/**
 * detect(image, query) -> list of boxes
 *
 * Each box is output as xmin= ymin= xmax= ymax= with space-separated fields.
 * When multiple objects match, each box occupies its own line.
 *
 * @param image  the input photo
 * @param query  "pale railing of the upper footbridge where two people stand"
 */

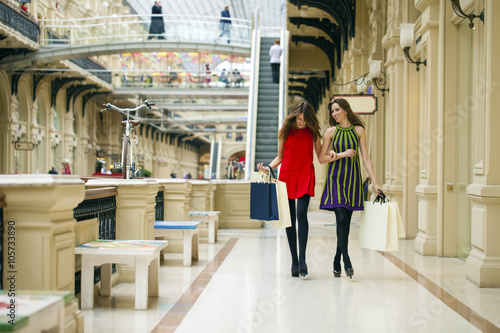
xmin=39 ymin=15 xmax=251 ymax=47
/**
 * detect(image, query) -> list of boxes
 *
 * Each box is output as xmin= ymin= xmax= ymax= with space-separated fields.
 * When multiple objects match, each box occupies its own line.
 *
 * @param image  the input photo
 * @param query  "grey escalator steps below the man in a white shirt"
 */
xmin=255 ymin=37 xmax=279 ymax=165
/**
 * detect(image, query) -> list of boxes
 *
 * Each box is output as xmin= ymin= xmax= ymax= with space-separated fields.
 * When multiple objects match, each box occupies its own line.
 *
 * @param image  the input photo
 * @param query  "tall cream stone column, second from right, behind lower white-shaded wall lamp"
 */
xmin=412 ymin=0 xmax=442 ymax=255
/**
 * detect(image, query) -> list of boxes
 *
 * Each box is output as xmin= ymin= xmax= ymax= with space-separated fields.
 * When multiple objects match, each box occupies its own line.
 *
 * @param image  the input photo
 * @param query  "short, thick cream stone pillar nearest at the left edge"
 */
xmin=0 ymin=175 xmax=85 ymax=290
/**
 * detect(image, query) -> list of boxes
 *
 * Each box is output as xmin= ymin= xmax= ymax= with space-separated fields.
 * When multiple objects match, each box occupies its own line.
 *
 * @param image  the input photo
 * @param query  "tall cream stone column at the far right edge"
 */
xmin=466 ymin=0 xmax=500 ymax=287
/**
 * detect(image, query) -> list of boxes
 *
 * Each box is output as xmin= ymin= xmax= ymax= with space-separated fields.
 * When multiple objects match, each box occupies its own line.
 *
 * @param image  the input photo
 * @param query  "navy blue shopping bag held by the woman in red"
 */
xmin=250 ymin=170 xmax=279 ymax=221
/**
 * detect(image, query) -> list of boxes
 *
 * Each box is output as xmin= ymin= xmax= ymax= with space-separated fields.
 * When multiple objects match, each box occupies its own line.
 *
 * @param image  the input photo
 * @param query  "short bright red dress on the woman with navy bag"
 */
xmin=278 ymin=127 xmax=316 ymax=199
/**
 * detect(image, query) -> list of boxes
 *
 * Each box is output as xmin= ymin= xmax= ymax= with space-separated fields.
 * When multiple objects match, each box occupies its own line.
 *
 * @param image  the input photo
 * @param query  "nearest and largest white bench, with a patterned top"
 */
xmin=75 ymin=239 xmax=167 ymax=310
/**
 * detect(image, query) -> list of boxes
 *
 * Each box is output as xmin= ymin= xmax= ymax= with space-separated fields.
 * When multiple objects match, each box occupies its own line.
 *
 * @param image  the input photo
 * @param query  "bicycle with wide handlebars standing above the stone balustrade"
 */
xmin=101 ymin=101 xmax=154 ymax=179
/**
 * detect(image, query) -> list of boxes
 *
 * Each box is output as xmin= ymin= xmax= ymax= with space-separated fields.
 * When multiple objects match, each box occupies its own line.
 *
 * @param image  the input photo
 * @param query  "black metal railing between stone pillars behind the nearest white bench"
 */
xmin=73 ymin=187 xmax=118 ymax=295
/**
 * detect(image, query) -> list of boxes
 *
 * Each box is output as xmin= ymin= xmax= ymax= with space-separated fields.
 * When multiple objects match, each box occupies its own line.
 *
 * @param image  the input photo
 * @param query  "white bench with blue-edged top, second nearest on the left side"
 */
xmin=155 ymin=221 xmax=202 ymax=266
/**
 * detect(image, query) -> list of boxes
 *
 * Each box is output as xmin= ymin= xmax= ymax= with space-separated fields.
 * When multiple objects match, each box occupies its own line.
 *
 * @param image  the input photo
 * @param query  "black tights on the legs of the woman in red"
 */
xmin=285 ymin=194 xmax=311 ymax=265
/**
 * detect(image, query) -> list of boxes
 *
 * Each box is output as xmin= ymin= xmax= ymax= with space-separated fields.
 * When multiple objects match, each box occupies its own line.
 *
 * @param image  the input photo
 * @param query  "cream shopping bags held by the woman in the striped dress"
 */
xmin=359 ymin=196 xmax=405 ymax=251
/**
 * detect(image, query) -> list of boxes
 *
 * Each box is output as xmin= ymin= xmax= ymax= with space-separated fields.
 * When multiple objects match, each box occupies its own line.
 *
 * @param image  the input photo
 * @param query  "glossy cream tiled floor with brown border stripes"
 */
xmin=82 ymin=212 xmax=500 ymax=333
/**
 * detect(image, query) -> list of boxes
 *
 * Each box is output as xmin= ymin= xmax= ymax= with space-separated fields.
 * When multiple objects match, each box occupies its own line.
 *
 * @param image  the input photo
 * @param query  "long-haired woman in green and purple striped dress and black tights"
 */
xmin=319 ymin=98 xmax=383 ymax=278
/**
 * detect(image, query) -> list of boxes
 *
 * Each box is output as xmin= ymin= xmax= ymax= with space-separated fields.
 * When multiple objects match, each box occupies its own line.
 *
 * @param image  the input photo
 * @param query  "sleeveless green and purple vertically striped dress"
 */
xmin=319 ymin=125 xmax=364 ymax=210
